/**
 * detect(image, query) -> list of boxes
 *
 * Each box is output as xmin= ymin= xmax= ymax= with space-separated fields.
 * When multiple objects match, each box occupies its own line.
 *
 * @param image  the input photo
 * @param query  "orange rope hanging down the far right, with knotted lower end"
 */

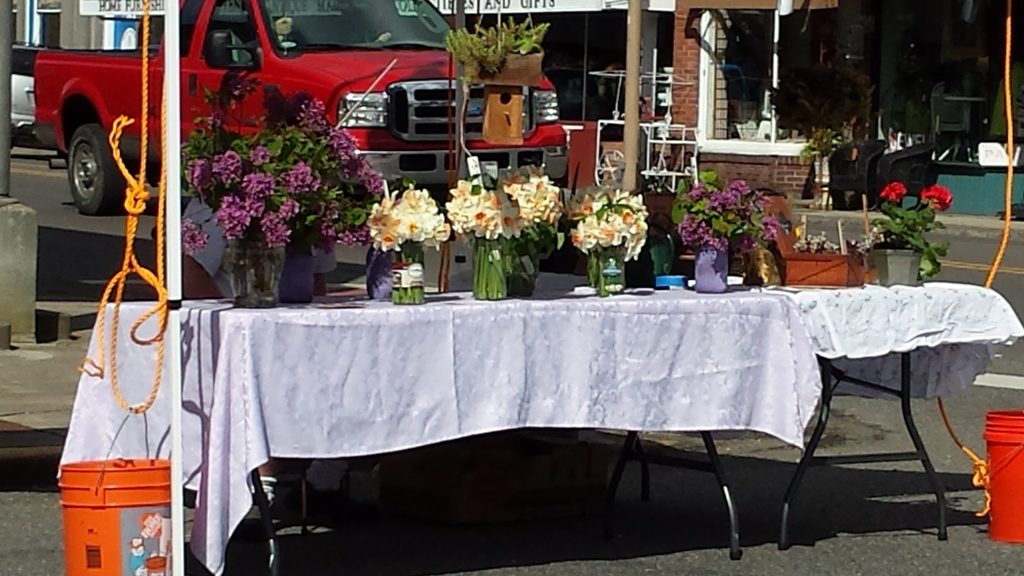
xmin=938 ymin=0 xmax=1016 ymax=517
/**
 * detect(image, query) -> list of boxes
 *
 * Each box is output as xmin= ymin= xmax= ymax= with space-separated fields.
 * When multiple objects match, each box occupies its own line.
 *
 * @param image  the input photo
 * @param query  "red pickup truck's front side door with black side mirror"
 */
xmin=181 ymin=0 xmax=262 ymax=131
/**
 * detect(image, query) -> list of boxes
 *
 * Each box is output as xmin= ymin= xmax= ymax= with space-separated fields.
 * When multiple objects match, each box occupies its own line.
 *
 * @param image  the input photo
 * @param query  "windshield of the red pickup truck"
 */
xmin=260 ymin=0 xmax=449 ymax=52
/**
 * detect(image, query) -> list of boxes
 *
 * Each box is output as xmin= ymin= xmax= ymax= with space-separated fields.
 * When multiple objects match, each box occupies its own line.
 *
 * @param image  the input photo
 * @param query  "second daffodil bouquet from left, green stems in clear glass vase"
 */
xmin=445 ymin=178 xmax=523 ymax=300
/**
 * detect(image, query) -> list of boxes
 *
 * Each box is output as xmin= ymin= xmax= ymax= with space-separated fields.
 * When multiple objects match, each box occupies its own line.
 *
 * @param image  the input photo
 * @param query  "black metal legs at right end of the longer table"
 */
xmin=604 ymin=431 xmax=743 ymax=560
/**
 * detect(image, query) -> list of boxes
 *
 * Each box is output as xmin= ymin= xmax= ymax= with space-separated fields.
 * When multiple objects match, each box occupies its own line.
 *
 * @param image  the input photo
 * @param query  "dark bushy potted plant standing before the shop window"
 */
xmin=771 ymin=65 xmax=873 ymax=206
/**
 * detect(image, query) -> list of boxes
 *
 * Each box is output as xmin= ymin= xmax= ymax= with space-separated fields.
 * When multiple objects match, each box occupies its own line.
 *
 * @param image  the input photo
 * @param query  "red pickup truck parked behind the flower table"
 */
xmin=35 ymin=0 xmax=566 ymax=214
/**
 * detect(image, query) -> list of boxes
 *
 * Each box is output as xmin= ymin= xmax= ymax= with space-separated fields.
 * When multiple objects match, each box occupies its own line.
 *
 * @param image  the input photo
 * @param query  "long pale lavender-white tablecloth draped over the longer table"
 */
xmin=62 ymin=292 xmax=820 ymax=574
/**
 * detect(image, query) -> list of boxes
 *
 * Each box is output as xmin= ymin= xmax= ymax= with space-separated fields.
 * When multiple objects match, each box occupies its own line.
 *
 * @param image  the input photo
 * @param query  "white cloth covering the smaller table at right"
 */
xmin=768 ymin=282 xmax=1024 ymax=398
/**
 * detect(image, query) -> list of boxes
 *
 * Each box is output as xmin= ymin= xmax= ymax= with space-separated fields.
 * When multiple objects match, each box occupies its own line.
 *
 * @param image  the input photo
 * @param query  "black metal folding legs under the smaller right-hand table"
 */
xmin=778 ymin=353 xmax=947 ymax=550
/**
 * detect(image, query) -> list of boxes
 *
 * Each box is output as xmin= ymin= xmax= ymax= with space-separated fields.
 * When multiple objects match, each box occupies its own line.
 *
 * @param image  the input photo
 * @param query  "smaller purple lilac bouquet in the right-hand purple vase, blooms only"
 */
xmin=674 ymin=171 xmax=779 ymax=251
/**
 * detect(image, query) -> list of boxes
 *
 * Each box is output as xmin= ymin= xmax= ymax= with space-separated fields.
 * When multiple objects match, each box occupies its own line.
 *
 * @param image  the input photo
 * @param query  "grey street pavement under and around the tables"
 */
xmin=0 ymin=150 xmax=1024 ymax=576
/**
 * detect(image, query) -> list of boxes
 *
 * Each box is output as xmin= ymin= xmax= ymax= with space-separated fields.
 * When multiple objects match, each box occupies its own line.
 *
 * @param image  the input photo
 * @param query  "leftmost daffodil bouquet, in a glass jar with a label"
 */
xmin=370 ymin=187 xmax=452 ymax=304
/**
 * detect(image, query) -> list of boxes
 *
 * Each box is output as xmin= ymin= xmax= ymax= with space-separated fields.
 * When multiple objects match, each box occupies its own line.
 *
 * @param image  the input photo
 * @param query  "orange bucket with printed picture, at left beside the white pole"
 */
xmin=59 ymin=460 xmax=171 ymax=576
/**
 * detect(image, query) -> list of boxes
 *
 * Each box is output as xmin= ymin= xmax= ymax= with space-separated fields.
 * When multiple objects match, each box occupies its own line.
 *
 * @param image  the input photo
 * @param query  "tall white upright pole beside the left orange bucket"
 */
xmin=162 ymin=1 xmax=185 ymax=576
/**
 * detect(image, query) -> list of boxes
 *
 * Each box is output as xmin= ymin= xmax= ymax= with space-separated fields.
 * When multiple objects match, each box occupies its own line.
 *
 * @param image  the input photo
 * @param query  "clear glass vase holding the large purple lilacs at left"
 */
xmin=224 ymin=239 xmax=285 ymax=308
